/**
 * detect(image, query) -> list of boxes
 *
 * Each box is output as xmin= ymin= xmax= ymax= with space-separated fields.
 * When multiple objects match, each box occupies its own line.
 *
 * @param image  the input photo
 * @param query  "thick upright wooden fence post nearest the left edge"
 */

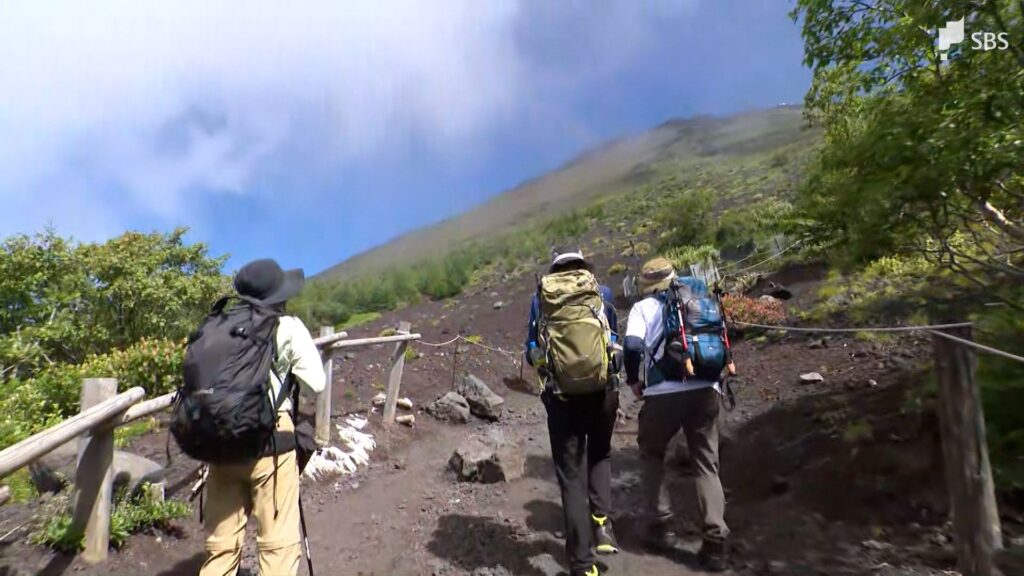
xmin=72 ymin=378 xmax=118 ymax=564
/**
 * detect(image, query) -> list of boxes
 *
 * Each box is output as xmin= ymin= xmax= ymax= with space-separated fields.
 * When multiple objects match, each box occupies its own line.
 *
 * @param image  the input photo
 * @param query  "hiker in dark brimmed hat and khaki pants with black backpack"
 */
xmin=172 ymin=259 xmax=326 ymax=576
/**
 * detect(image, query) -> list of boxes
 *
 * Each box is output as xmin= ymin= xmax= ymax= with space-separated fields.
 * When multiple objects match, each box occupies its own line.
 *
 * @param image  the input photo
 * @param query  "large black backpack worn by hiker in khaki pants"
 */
xmin=170 ymin=297 xmax=290 ymax=464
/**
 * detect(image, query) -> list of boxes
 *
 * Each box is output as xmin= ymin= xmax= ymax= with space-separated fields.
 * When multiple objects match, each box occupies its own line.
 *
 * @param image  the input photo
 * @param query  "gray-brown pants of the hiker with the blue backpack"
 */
xmin=637 ymin=387 xmax=729 ymax=543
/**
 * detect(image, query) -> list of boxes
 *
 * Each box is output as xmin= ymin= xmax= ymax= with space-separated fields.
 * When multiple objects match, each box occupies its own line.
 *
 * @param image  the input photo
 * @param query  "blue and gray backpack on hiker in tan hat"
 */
xmin=657 ymin=276 xmax=729 ymax=381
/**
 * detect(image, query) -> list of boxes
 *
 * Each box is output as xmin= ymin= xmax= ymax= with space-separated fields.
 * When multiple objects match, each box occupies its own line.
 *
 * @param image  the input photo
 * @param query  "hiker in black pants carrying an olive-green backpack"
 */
xmin=525 ymin=248 xmax=622 ymax=576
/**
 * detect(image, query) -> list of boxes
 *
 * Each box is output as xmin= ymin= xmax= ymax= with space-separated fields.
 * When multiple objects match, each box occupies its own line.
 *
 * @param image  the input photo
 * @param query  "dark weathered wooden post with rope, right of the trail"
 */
xmin=932 ymin=328 xmax=1002 ymax=576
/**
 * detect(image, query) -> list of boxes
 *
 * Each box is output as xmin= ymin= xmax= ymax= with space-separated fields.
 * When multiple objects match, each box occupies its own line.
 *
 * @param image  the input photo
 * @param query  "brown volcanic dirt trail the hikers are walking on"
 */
xmin=0 ymin=261 xmax=1021 ymax=576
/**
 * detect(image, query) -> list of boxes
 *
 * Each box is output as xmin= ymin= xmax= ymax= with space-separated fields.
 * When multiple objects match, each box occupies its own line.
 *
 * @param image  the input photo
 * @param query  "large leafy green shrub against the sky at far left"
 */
xmin=0 ymin=229 xmax=229 ymax=379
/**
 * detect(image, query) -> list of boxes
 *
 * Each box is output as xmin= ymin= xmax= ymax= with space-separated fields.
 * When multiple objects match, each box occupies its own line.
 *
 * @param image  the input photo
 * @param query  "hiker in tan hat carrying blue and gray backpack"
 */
xmin=624 ymin=258 xmax=731 ymax=571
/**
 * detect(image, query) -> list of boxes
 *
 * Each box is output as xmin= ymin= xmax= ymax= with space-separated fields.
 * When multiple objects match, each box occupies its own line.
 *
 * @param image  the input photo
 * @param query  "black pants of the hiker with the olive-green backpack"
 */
xmin=541 ymin=390 xmax=618 ymax=574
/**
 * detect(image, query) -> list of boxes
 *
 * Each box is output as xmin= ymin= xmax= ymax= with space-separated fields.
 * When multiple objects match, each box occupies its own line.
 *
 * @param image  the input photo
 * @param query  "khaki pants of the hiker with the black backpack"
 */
xmin=200 ymin=414 xmax=302 ymax=576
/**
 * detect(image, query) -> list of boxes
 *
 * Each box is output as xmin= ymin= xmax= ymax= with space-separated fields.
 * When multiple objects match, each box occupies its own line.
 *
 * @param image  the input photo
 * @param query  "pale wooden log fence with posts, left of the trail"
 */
xmin=0 ymin=322 xmax=420 ymax=564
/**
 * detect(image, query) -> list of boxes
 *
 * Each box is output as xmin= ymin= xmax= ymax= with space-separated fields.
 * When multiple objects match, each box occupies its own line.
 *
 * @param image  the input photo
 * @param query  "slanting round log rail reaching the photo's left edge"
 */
xmin=0 ymin=387 xmax=145 ymax=478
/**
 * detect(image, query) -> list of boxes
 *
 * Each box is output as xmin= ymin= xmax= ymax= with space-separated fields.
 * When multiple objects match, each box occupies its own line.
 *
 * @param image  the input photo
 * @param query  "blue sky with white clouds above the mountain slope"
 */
xmin=0 ymin=0 xmax=810 ymax=274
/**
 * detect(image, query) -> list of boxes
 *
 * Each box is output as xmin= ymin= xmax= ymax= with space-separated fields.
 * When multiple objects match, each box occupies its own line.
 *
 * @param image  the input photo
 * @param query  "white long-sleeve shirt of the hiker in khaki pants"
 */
xmin=270 ymin=316 xmax=327 ymax=412
